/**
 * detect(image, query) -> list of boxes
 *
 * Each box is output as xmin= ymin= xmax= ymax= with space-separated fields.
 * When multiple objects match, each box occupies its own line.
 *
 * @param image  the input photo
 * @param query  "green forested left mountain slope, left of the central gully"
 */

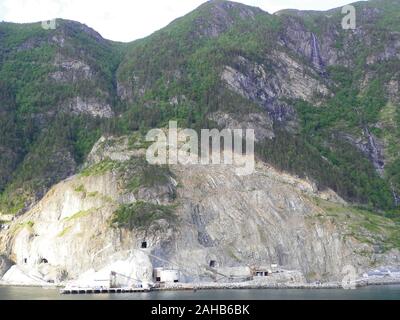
xmin=0 ymin=20 xmax=123 ymax=213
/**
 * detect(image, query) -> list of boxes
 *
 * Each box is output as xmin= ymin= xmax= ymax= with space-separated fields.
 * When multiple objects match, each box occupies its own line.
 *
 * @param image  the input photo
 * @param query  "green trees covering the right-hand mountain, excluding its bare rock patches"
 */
xmin=114 ymin=1 xmax=400 ymax=215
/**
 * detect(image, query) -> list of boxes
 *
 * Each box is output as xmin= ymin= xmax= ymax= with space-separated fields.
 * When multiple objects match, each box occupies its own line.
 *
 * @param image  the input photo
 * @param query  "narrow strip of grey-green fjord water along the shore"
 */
xmin=0 ymin=285 xmax=400 ymax=300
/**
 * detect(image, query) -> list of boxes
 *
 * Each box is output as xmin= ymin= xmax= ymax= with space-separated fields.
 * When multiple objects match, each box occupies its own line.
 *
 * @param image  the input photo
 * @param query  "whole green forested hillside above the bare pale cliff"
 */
xmin=0 ymin=0 xmax=400 ymax=215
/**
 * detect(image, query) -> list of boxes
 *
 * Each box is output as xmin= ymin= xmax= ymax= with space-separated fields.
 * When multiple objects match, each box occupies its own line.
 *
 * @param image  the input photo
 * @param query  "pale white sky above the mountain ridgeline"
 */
xmin=0 ymin=0 xmax=353 ymax=42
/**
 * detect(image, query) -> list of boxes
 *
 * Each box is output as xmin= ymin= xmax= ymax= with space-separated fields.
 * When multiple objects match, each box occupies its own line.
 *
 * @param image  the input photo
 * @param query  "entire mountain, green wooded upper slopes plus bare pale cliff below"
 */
xmin=0 ymin=0 xmax=400 ymax=281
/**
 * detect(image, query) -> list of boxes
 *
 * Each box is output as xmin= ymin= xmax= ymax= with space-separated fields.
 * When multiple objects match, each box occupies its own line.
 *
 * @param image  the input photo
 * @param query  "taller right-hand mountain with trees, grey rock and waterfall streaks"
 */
xmin=118 ymin=1 xmax=399 ymax=210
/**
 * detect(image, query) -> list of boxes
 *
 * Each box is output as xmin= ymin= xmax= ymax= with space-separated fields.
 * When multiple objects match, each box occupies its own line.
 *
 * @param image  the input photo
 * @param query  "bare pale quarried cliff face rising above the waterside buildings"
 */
xmin=0 ymin=137 xmax=400 ymax=283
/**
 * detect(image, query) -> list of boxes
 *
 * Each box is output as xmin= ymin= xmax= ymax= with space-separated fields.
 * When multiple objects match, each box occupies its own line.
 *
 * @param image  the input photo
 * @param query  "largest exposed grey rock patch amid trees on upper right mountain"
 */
xmin=221 ymin=51 xmax=329 ymax=127
